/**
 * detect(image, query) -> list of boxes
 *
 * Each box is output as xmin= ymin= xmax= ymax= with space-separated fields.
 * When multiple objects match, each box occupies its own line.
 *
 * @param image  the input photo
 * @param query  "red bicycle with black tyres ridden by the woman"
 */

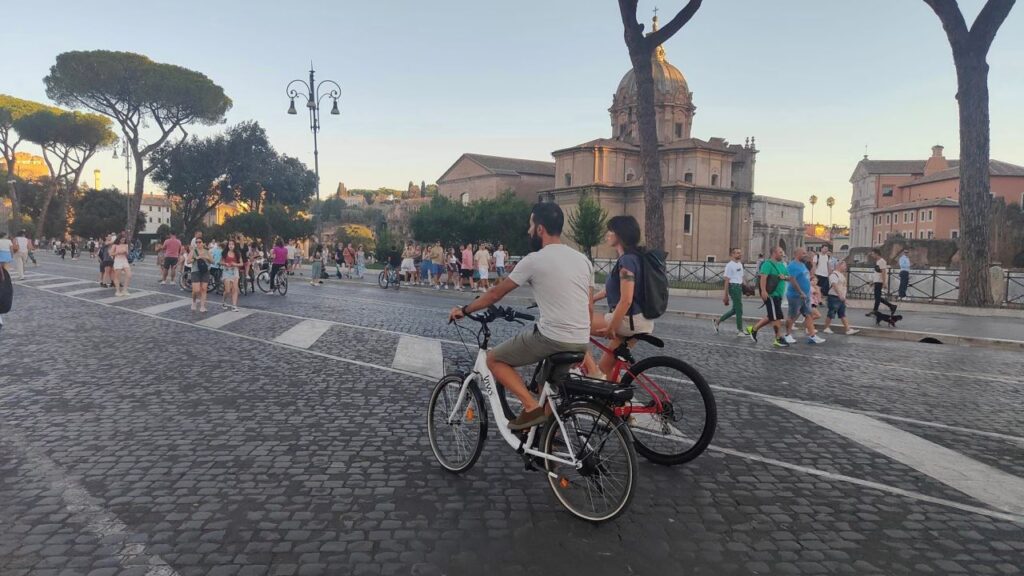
xmin=498 ymin=334 xmax=718 ymax=465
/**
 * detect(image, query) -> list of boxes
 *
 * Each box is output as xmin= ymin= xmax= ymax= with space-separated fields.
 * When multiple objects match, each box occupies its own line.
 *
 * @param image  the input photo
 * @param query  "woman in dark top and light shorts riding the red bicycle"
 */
xmin=584 ymin=216 xmax=654 ymax=379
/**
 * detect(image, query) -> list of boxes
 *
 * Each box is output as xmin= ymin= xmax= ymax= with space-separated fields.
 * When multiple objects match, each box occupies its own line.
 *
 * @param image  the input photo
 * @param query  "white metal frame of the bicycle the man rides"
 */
xmin=447 ymin=347 xmax=583 ymax=467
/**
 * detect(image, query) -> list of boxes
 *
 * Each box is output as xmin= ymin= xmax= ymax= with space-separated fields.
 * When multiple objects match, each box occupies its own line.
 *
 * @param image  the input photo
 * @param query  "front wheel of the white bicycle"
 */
xmin=427 ymin=374 xmax=487 ymax=474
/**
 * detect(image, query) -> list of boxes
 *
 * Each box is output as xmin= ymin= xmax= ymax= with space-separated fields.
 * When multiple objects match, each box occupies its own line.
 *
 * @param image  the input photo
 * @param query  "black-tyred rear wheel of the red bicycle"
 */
xmin=623 ymin=356 xmax=718 ymax=465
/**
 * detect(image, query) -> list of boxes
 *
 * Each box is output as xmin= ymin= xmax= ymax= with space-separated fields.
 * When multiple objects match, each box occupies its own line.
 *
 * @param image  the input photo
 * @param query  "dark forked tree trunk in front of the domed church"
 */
xmin=618 ymin=0 xmax=701 ymax=252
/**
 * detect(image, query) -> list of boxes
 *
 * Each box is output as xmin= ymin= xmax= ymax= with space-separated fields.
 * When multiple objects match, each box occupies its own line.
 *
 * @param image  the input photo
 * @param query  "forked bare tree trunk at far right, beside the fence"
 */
xmin=925 ymin=0 xmax=1016 ymax=306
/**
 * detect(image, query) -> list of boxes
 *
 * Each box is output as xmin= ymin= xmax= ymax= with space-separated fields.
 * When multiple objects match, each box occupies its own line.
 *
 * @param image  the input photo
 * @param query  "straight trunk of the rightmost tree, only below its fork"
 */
xmin=956 ymin=55 xmax=992 ymax=306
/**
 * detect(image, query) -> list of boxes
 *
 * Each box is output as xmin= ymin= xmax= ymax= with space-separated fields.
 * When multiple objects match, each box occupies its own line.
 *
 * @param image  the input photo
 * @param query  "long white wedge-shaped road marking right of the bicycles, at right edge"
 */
xmin=772 ymin=400 xmax=1024 ymax=516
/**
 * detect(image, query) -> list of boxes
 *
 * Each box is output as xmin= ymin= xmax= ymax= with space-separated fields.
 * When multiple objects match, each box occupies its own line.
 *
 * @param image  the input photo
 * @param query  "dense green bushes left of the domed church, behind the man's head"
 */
xmin=410 ymin=193 xmax=530 ymax=254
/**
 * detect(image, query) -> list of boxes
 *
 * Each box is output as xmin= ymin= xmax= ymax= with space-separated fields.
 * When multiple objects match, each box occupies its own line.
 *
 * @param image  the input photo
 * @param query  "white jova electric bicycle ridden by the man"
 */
xmin=427 ymin=306 xmax=638 ymax=522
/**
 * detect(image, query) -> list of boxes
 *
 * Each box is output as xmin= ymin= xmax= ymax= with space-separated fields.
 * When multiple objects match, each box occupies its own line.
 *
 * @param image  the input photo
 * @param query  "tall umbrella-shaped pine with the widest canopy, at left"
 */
xmin=43 ymin=50 xmax=231 ymax=238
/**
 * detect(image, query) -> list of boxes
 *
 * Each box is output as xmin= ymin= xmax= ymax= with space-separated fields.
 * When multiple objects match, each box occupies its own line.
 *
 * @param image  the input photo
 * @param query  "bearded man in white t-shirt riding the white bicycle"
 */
xmin=449 ymin=202 xmax=593 ymax=430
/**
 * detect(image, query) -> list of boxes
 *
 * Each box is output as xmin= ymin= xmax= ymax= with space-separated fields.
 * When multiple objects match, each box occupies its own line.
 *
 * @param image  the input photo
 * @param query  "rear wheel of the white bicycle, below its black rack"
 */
xmin=544 ymin=401 xmax=638 ymax=522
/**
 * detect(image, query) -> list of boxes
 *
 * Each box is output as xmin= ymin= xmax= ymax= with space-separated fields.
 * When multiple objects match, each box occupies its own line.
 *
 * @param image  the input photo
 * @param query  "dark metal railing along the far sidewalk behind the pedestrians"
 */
xmin=594 ymin=258 xmax=1024 ymax=307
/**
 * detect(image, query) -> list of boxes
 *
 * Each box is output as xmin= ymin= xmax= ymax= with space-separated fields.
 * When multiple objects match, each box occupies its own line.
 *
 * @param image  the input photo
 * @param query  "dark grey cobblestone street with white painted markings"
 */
xmin=0 ymin=256 xmax=1024 ymax=576
